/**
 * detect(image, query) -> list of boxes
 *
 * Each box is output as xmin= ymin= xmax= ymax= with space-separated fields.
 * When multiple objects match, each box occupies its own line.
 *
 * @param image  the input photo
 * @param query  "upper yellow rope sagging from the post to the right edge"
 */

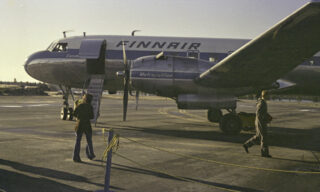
xmin=122 ymin=136 xmax=320 ymax=175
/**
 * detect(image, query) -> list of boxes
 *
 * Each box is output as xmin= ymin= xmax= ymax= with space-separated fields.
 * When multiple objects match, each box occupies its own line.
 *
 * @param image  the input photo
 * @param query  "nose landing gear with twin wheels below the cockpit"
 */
xmin=60 ymin=85 xmax=74 ymax=121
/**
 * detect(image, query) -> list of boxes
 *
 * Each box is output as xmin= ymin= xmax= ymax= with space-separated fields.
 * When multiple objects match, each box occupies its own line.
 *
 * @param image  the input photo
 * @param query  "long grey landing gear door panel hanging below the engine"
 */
xmin=177 ymin=94 xmax=237 ymax=109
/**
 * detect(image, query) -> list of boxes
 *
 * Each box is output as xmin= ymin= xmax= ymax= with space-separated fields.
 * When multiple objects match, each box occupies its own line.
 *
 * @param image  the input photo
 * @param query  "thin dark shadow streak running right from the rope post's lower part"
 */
xmin=112 ymin=163 xmax=260 ymax=192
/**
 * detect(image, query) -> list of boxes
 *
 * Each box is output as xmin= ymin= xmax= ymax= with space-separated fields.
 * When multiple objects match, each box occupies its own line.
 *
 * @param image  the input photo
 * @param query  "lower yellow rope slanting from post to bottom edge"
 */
xmin=115 ymin=152 xmax=239 ymax=192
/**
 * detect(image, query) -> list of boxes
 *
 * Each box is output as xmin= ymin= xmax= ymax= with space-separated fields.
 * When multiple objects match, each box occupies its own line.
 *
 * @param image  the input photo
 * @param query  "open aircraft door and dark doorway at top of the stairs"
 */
xmin=79 ymin=39 xmax=107 ymax=75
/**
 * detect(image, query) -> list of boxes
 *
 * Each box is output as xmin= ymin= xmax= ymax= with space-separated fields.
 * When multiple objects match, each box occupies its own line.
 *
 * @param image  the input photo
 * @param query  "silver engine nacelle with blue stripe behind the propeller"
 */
xmin=130 ymin=56 xmax=213 ymax=97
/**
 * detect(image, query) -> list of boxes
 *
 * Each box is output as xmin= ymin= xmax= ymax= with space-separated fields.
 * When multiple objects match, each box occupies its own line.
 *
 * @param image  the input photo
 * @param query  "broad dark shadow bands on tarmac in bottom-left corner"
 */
xmin=0 ymin=159 xmax=123 ymax=191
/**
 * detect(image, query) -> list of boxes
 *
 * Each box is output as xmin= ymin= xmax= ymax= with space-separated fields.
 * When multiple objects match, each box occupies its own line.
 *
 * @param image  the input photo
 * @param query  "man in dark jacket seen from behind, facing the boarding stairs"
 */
xmin=73 ymin=94 xmax=95 ymax=162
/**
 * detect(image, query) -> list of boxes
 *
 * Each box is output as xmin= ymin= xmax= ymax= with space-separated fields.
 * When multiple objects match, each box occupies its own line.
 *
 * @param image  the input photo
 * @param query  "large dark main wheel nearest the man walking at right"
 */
xmin=220 ymin=113 xmax=242 ymax=135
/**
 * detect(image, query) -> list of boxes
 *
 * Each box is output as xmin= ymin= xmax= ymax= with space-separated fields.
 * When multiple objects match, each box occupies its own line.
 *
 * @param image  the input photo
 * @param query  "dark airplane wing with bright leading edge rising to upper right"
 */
xmin=196 ymin=0 xmax=320 ymax=88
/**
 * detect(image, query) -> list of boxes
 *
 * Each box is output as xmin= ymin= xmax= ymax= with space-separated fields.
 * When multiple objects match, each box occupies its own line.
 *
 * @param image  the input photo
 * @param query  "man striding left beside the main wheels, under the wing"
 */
xmin=243 ymin=91 xmax=271 ymax=157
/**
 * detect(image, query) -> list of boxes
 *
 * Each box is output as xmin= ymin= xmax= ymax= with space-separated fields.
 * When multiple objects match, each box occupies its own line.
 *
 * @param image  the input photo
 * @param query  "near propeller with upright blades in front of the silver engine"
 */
xmin=122 ymin=41 xmax=130 ymax=121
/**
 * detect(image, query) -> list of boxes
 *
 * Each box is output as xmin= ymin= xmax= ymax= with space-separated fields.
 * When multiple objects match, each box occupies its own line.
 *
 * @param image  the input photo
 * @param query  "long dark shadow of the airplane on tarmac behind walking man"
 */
xmin=102 ymin=123 xmax=320 ymax=152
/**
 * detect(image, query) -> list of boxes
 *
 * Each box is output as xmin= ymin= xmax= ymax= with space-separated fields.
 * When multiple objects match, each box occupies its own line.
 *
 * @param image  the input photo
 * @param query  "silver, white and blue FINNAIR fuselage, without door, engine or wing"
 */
xmin=25 ymin=36 xmax=320 ymax=97
